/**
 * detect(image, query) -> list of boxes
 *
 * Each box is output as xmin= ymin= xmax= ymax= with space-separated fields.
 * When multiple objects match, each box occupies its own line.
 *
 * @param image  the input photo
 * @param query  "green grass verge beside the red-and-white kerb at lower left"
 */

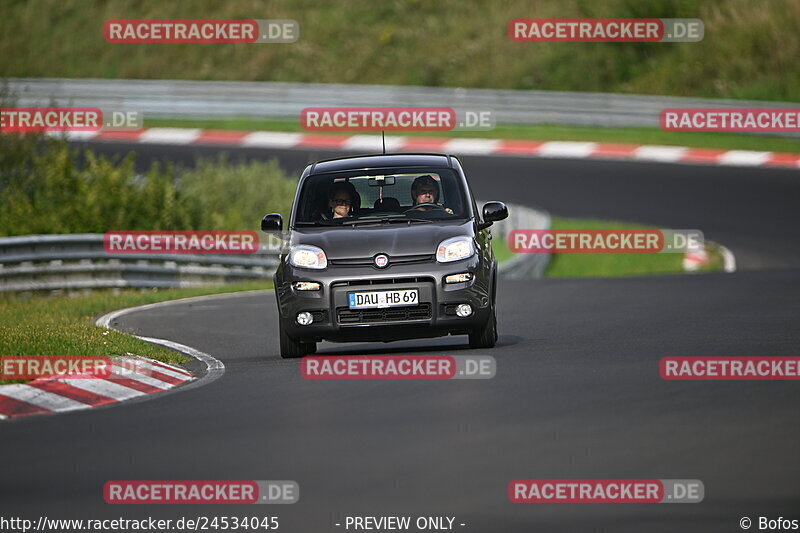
xmin=0 ymin=280 xmax=272 ymax=384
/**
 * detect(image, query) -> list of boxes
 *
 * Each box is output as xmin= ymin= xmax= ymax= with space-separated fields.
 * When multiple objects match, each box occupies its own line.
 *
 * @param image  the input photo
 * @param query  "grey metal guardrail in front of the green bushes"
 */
xmin=0 ymin=233 xmax=278 ymax=292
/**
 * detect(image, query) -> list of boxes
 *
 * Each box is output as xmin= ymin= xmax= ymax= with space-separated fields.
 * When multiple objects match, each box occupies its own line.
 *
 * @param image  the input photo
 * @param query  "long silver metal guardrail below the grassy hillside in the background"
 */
xmin=6 ymin=78 xmax=800 ymax=135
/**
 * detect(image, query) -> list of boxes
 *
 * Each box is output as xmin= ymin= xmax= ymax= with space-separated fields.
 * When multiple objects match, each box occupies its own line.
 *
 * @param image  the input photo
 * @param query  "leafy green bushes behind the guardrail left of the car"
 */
xmin=0 ymin=135 xmax=295 ymax=235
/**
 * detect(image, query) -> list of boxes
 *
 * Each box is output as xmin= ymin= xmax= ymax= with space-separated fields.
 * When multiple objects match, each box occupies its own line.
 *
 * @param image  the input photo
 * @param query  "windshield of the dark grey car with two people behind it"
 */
xmin=295 ymin=168 xmax=468 ymax=226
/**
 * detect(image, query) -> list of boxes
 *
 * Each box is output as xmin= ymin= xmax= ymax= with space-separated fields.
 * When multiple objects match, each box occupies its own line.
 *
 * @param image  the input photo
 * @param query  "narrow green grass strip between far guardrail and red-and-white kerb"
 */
xmin=145 ymin=118 xmax=800 ymax=153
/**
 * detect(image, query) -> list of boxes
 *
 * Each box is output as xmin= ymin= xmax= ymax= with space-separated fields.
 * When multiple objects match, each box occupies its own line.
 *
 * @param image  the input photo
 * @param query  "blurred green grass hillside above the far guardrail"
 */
xmin=0 ymin=0 xmax=800 ymax=101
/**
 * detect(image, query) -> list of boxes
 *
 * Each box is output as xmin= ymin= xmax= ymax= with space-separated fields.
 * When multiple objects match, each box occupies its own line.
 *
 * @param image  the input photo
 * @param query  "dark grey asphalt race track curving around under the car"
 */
xmin=0 ymin=144 xmax=800 ymax=532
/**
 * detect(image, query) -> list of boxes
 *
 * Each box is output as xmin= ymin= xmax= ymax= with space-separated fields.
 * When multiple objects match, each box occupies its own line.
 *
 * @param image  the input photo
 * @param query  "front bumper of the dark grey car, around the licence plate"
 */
xmin=275 ymin=256 xmax=491 ymax=342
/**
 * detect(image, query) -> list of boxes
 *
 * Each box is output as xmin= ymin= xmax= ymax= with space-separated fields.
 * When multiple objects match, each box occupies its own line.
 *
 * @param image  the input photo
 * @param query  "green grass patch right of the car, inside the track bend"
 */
xmin=544 ymin=217 xmax=722 ymax=278
